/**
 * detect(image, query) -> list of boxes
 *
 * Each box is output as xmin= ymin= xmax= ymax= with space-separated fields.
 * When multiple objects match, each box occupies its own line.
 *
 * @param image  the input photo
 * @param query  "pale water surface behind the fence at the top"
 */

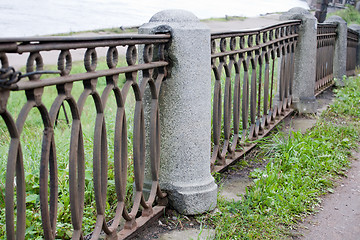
xmin=0 ymin=0 xmax=308 ymax=37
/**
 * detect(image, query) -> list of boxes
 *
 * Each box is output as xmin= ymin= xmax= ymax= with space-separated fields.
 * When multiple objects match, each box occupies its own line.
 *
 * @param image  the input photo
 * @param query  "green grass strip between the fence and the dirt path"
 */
xmin=207 ymin=74 xmax=360 ymax=239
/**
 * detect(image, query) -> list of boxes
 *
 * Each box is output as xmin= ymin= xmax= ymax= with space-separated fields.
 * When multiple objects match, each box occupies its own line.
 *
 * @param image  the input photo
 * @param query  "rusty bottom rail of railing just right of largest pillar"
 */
xmin=214 ymin=108 xmax=294 ymax=173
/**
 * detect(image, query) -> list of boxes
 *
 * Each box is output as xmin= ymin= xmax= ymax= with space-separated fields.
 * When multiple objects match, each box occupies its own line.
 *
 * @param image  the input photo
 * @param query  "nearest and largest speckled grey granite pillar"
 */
xmin=139 ymin=10 xmax=217 ymax=215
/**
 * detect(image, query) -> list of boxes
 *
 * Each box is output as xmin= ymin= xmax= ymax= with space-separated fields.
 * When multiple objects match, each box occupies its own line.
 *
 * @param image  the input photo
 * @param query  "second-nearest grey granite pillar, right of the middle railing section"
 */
xmin=280 ymin=8 xmax=317 ymax=113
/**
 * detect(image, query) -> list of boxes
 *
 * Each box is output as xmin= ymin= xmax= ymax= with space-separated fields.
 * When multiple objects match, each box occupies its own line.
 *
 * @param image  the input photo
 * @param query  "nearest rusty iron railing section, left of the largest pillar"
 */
xmin=0 ymin=34 xmax=170 ymax=239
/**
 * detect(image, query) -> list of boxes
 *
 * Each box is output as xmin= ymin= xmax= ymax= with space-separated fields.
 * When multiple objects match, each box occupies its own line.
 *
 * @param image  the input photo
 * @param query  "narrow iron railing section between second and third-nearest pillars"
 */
xmin=315 ymin=23 xmax=336 ymax=94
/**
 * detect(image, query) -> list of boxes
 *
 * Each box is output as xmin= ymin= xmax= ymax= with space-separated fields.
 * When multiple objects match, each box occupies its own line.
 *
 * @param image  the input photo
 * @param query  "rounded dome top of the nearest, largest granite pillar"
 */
xmin=149 ymin=9 xmax=199 ymax=23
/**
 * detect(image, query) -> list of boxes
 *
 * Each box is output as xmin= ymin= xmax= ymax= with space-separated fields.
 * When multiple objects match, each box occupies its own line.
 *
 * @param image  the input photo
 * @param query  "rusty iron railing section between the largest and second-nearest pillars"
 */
xmin=211 ymin=21 xmax=301 ymax=171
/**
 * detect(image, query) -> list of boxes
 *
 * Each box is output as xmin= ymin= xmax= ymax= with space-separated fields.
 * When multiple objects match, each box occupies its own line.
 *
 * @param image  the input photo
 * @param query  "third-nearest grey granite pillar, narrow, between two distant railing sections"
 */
xmin=325 ymin=15 xmax=347 ymax=86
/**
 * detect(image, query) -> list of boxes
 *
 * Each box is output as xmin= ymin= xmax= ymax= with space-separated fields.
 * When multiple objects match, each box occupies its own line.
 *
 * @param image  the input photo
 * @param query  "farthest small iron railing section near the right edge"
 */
xmin=346 ymin=28 xmax=359 ymax=76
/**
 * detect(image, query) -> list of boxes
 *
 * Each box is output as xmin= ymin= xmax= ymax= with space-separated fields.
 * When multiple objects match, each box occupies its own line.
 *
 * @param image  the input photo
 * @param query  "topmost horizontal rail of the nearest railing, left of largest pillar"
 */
xmin=0 ymin=34 xmax=171 ymax=53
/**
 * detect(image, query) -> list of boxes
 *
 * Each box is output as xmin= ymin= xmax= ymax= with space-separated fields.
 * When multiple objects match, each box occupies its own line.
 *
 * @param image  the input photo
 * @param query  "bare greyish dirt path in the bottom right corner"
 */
xmin=299 ymin=149 xmax=360 ymax=240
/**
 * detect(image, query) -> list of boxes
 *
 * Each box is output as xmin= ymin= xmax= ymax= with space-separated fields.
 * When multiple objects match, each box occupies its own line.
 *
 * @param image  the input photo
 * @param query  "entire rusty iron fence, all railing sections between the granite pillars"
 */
xmin=0 ymin=15 xmax=358 ymax=239
